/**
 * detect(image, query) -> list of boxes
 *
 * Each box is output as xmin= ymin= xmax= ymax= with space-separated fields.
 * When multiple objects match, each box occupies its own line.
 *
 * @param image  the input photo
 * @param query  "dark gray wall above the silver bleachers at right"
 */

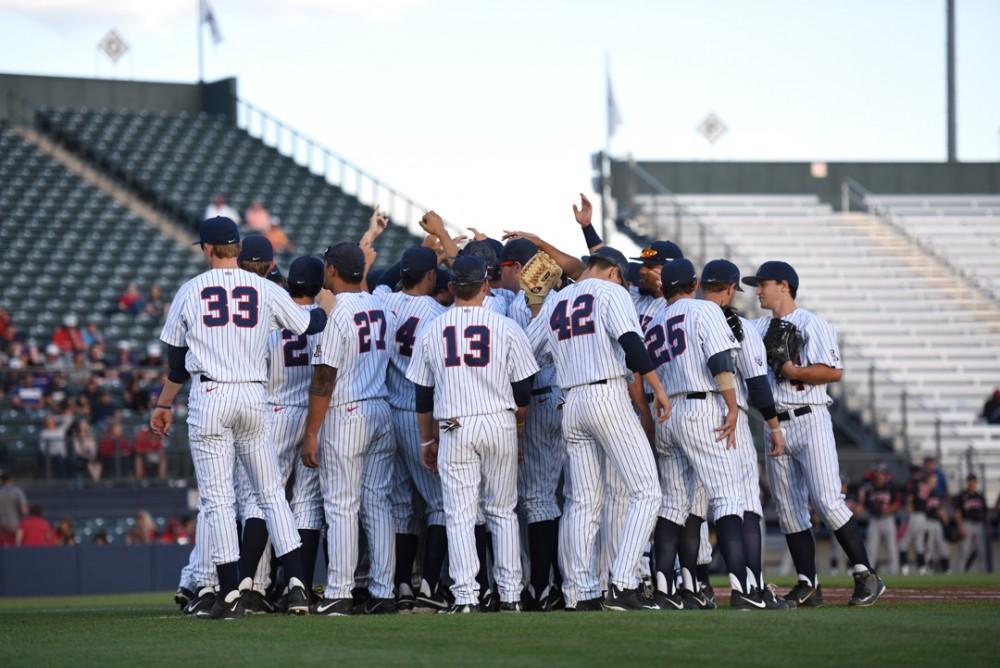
xmin=611 ymin=160 xmax=1000 ymax=209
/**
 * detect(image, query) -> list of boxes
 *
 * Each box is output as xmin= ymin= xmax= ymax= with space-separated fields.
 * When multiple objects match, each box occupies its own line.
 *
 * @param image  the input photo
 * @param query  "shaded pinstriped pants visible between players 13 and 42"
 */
xmin=517 ymin=388 xmax=566 ymax=524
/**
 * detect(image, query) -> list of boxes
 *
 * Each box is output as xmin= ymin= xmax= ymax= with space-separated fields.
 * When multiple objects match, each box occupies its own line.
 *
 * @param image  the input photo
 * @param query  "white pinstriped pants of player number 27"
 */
xmin=319 ymin=399 xmax=396 ymax=598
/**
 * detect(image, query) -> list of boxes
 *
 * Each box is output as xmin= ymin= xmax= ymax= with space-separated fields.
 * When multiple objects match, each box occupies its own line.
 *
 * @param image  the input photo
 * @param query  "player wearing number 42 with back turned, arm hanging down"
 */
xmin=528 ymin=246 xmax=670 ymax=611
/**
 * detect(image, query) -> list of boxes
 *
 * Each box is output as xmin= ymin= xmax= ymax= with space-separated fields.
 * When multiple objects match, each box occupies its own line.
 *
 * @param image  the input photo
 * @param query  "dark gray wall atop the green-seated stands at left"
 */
xmin=0 ymin=73 xmax=236 ymax=125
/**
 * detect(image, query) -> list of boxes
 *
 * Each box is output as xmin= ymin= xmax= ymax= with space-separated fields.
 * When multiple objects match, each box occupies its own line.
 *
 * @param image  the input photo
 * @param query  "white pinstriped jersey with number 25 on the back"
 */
xmin=646 ymin=297 xmax=740 ymax=396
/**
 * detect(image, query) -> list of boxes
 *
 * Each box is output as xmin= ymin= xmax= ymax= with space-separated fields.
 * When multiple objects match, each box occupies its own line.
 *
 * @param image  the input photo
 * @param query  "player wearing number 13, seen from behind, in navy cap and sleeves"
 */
xmin=406 ymin=256 xmax=538 ymax=613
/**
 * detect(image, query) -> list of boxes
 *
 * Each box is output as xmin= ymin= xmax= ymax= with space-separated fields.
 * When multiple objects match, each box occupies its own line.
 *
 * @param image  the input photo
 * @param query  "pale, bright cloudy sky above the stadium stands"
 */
xmin=0 ymin=0 xmax=1000 ymax=250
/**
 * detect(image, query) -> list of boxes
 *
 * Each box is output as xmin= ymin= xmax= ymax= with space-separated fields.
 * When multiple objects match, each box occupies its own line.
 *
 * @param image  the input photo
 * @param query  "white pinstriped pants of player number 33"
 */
xmin=188 ymin=378 xmax=301 ymax=565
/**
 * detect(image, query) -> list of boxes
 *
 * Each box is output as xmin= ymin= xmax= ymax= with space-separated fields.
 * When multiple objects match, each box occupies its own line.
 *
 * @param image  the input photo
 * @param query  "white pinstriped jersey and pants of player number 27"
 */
xmin=312 ymin=292 xmax=396 ymax=598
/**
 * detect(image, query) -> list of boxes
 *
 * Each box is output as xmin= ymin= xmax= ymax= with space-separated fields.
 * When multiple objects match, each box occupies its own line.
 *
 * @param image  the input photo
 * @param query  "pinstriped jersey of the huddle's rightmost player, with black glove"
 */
xmin=753 ymin=308 xmax=844 ymax=406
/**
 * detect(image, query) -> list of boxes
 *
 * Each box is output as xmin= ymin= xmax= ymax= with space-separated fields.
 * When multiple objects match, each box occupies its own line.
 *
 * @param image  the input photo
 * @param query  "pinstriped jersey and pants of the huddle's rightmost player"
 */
xmin=752 ymin=308 xmax=851 ymax=534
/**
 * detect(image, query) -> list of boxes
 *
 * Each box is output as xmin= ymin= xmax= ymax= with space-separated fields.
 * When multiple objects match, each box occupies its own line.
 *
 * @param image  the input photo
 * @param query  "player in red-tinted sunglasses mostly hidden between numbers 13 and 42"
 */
xmin=500 ymin=239 xmax=566 ymax=611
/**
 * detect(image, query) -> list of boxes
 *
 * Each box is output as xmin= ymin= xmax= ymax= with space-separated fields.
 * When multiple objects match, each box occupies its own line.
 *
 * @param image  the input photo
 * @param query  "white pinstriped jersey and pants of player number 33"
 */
xmin=160 ymin=268 xmax=309 ymax=564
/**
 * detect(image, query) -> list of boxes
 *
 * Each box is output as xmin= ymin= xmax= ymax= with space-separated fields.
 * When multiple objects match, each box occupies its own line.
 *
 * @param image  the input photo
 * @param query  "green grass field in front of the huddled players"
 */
xmin=0 ymin=576 xmax=1000 ymax=668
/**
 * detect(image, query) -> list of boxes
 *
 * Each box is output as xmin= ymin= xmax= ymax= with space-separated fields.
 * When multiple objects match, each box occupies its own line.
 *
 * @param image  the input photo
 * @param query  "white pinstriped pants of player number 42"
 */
xmin=559 ymin=379 xmax=659 ymax=604
